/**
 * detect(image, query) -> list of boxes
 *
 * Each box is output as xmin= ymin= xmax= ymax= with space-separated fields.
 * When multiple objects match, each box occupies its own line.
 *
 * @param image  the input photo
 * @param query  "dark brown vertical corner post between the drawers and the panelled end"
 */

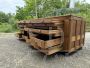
xmin=63 ymin=19 xmax=71 ymax=52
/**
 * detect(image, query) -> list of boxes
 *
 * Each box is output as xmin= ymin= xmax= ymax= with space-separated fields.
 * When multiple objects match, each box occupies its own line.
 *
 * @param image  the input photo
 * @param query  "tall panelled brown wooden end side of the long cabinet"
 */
xmin=63 ymin=16 xmax=85 ymax=53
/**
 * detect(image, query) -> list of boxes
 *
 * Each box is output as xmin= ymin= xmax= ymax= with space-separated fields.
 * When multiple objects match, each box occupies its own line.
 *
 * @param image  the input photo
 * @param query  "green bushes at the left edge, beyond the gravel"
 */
xmin=0 ymin=12 xmax=17 ymax=32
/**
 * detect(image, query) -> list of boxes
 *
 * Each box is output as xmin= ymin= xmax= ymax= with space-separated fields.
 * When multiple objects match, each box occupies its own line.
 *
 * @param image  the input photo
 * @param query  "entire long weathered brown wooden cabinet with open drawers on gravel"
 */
xmin=17 ymin=15 xmax=85 ymax=55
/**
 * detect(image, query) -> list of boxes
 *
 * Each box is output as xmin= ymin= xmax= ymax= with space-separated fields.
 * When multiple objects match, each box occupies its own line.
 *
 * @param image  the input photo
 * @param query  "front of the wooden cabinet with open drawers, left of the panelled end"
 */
xmin=17 ymin=21 xmax=64 ymax=55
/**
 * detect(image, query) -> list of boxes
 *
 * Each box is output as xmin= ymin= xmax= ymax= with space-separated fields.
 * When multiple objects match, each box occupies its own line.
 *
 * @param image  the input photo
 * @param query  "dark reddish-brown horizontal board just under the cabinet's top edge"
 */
xmin=26 ymin=23 xmax=63 ymax=30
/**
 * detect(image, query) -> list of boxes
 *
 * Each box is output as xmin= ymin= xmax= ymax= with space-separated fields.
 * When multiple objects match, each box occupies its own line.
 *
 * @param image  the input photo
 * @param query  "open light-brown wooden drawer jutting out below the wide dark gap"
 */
xmin=30 ymin=36 xmax=63 ymax=49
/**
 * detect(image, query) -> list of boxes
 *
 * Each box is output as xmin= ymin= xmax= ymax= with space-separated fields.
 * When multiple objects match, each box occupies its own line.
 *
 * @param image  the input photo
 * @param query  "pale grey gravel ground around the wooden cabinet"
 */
xmin=0 ymin=33 xmax=90 ymax=68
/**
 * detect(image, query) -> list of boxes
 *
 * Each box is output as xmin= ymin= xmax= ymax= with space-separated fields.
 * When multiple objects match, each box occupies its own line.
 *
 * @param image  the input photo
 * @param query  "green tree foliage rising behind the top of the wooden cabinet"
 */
xmin=16 ymin=0 xmax=90 ymax=21
